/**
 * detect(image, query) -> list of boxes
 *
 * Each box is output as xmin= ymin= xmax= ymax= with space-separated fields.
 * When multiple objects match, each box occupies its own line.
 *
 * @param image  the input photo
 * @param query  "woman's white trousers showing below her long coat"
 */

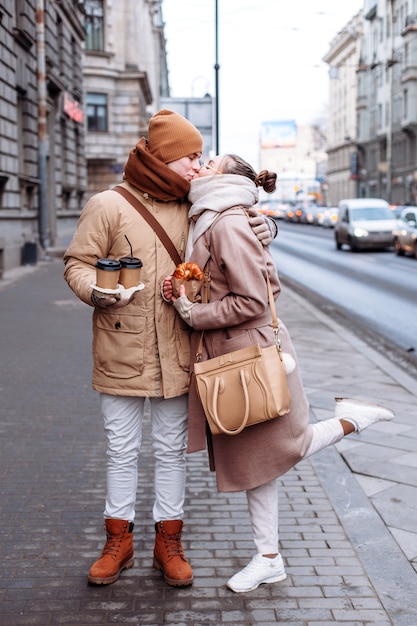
xmin=246 ymin=418 xmax=344 ymax=554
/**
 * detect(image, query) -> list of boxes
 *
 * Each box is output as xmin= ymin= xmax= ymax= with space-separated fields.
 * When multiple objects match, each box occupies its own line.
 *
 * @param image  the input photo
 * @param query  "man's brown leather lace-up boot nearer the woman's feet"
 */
xmin=153 ymin=520 xmax=193 ymax=587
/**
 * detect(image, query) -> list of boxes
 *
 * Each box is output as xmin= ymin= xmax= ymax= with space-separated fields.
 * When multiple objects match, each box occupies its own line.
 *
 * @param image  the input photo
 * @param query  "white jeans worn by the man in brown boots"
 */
xmin=101 ymin=394 xmax=188 ymax=522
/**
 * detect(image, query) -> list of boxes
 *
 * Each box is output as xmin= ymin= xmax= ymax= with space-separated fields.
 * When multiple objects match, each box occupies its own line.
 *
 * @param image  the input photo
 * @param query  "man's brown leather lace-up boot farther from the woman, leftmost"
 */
xmin=88 ymin=519 xmax=134 ymax=585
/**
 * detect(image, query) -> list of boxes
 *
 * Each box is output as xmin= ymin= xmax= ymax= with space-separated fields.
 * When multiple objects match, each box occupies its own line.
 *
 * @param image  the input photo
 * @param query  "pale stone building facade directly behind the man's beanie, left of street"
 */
xmin=83 ymin=0 xmax=169 ymax=199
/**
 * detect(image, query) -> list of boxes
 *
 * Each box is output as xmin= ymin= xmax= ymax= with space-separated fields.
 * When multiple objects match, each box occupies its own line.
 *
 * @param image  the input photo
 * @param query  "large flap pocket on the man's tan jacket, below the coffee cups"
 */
xmin=93 ymin=313 xmax=146 ymax=379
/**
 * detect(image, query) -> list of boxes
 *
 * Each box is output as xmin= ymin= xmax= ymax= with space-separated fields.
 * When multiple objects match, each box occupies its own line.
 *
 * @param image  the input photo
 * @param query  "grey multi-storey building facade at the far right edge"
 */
xmin=357 ymin=0 xmax=417 ymax=204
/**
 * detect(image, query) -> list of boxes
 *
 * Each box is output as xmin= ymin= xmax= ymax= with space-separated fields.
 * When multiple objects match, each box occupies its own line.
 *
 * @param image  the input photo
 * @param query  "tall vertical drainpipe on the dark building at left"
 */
xmin=36 ymin=0 xmax=50 ymax=250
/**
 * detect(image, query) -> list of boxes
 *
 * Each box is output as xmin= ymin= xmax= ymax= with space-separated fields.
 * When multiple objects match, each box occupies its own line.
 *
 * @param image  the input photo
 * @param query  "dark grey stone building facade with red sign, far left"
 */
xmin=0 ymin=0 xmax=86 ymax=274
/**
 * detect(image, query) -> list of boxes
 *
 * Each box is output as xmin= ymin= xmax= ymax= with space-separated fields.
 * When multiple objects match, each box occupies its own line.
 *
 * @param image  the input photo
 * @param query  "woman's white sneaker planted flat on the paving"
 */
xmin=227 ymin=554 xmax=287 ymax=593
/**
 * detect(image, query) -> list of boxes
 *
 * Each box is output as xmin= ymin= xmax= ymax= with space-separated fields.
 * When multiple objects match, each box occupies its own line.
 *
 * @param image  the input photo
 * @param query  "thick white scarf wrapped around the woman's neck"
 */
xmin=185 ymin=174 xmax=259 ymax=261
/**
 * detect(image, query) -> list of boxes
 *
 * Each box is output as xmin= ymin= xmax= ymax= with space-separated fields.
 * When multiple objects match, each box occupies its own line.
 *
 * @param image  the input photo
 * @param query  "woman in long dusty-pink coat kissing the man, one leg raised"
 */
xmin=165 ymin=154 xmax=394 ymax=592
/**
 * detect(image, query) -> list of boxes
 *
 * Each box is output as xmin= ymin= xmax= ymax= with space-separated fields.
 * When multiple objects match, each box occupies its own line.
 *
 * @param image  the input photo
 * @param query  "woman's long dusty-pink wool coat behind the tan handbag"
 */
xmin=188 ymin=208 xmax=312 ymax=491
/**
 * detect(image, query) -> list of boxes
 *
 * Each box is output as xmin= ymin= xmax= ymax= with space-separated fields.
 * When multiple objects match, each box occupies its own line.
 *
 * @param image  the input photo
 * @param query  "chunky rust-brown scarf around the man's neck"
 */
xmin=124 ymin=137 xmax=190 ymax=201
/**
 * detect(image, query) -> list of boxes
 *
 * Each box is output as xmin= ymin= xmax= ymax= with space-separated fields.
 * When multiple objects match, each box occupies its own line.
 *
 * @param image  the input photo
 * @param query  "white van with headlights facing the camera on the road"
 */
xmin=334 ymin=198 xmax=398 ymax=252
